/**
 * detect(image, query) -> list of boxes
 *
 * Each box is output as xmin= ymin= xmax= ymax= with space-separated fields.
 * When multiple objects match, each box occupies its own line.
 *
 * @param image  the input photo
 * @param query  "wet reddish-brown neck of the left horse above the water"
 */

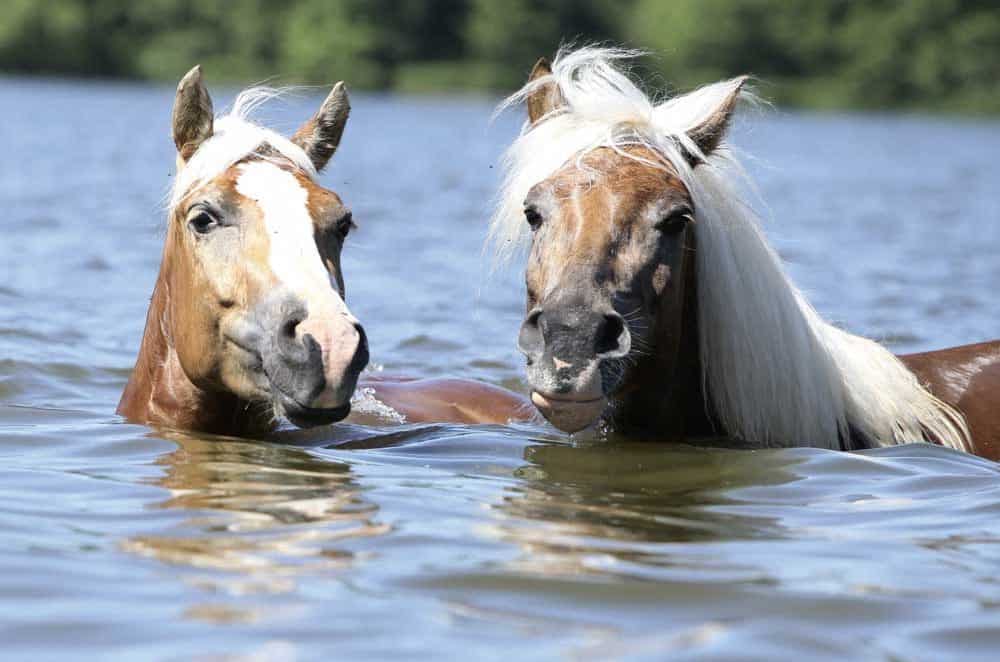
xmin=117 ymin=257 xmax=273 ymax=436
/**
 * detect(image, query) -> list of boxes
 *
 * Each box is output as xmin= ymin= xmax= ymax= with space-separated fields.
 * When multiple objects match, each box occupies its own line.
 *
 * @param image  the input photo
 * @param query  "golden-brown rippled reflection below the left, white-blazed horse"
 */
xmin=124 ymin=433 xmax=390 ymax=600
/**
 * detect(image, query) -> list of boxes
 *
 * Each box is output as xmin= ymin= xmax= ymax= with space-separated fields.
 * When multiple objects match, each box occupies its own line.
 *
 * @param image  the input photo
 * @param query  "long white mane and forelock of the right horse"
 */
xmin=490 ymin=47 xmax=971 ymax=450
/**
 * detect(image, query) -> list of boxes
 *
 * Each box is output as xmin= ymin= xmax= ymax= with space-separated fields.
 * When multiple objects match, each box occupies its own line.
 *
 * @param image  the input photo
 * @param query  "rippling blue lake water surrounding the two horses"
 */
xmin=0 ymin=79 xmax=1000 ymax=660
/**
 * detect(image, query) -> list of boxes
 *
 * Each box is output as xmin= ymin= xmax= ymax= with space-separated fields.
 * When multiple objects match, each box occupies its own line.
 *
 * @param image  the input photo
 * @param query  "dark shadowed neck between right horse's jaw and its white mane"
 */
xmin=613 ymin=237 xmax=716 ymax=438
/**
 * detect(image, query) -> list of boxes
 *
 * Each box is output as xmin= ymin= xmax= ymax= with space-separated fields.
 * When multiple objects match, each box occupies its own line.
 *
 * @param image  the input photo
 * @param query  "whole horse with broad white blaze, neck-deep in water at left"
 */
xmin=118 ymin=67 xmax=530 ymax=435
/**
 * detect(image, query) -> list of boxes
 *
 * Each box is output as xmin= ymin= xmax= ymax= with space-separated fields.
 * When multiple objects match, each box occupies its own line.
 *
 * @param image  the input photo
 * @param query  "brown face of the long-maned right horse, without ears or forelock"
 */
xmin=518 ymin=148 xmax=694 ymax=432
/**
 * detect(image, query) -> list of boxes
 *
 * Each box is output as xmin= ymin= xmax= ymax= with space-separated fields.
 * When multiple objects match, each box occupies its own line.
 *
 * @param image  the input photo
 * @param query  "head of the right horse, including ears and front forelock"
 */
xmin=494 ymin=54 xmax=744 ymax=432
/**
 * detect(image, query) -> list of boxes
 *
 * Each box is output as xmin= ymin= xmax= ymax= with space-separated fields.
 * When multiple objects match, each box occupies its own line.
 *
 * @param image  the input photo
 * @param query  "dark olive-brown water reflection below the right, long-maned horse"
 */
xmin=495 ymin=440 xmax=800 ymax=581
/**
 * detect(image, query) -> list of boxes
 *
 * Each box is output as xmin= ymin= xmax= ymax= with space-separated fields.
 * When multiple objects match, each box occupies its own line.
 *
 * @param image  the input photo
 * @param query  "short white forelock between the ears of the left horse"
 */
xmin=168 ymin=87 xmax=316 ymax=211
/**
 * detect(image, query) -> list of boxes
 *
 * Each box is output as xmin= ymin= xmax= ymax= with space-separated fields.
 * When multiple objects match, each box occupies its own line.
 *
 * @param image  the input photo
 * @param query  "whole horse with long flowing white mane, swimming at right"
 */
xmin=491 ymin=47 xmax=1000 ymax=458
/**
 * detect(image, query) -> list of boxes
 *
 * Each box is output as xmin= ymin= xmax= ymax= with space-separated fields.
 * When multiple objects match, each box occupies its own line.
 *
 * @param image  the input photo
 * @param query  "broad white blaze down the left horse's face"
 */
xmin=236 ymin=161 xmax=354 ymax=320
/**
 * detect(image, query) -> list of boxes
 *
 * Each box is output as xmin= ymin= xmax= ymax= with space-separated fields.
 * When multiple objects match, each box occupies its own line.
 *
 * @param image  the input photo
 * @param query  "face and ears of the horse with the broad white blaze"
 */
xmin=164 ymin=67 xmax=368 ymax=426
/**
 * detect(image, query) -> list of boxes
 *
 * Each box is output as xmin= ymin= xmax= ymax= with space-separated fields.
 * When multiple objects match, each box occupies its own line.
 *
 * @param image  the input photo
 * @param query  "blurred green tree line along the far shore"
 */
xmin=0 ymin=0 xmax=1000 ymax=113
